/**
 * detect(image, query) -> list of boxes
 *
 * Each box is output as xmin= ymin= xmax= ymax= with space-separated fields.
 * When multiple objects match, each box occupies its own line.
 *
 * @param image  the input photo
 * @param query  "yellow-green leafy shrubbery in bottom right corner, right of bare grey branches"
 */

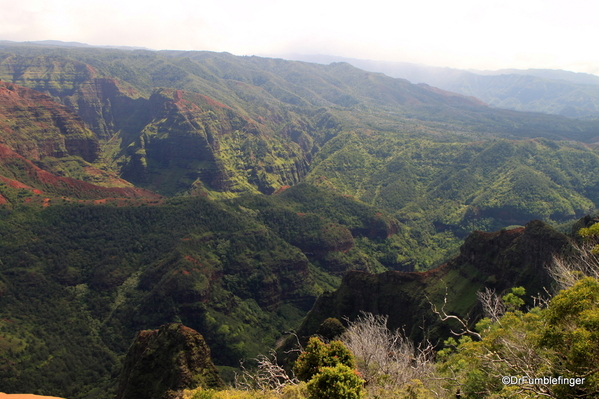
xmin=438 ymin=277 xmax=599 ymax=398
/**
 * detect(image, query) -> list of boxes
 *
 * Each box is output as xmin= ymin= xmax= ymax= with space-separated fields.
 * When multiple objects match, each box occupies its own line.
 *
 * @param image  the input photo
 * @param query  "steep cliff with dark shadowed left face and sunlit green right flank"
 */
xmin=117 ymin=89 xmax=308 ymax=195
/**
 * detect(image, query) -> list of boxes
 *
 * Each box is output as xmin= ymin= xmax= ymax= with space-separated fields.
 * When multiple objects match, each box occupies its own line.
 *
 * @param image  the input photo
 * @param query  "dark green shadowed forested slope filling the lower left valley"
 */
xmin=0 ymin=185 xmax=404 ymax=397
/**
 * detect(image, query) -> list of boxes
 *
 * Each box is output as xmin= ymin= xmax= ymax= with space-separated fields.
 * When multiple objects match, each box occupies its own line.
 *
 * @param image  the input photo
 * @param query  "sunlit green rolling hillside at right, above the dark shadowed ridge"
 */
xmin=306 ymin=133 xmax=599 ymax=266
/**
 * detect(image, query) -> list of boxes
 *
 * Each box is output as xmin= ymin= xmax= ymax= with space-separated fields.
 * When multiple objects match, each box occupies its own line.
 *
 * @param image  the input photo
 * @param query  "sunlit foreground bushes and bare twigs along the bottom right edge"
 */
xmin=186 ymin=277 xmax=599 ymax=399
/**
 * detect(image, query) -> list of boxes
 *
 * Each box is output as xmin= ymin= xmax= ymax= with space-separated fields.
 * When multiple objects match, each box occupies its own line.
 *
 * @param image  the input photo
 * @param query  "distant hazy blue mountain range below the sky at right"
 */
xmin=282 ymin=54 xmax=599 ymax=118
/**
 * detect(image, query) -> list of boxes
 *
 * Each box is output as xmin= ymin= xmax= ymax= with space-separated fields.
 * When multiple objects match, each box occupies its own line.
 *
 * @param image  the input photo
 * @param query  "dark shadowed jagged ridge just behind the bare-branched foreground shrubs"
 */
xmin=299 ymin=220 xmax=570 ymax=342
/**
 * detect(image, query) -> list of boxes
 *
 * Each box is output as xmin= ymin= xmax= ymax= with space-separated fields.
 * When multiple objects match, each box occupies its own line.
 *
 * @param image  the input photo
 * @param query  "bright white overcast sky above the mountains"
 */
xmin=0 ymin=0 xmax=599 ymax=74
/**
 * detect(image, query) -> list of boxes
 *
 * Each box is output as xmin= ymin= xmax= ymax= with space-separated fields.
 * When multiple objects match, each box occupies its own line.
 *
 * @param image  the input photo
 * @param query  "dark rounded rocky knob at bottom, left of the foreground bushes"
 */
xmin=115 ymin=324 xmax=224 ymax=399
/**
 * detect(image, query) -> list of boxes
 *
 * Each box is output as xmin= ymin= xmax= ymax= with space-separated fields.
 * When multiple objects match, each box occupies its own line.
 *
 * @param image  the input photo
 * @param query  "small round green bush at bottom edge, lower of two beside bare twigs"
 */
xmin=308 ymin=364 xmax=366 ymax=399
